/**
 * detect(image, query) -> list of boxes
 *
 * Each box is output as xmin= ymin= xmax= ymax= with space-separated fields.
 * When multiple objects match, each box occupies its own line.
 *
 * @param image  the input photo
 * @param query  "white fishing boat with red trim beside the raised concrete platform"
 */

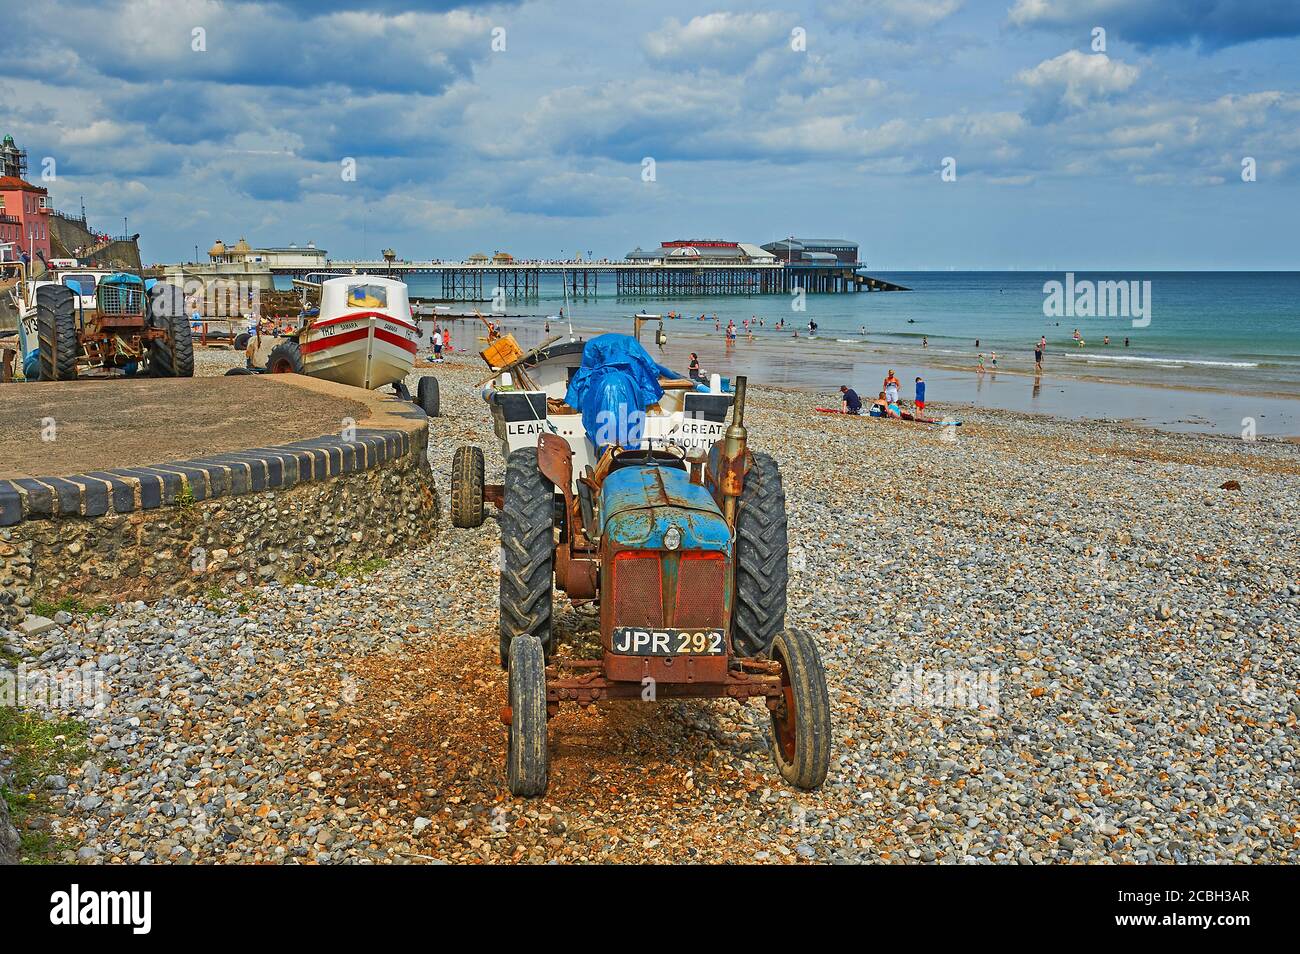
xmin=267 ymin=274 xmax=420 ymax=390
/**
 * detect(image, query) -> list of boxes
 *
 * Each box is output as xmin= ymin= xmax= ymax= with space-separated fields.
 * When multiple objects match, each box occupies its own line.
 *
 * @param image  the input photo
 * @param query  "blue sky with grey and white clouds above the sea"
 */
xmin=0 ymin=0 xmax=1300 ymax=270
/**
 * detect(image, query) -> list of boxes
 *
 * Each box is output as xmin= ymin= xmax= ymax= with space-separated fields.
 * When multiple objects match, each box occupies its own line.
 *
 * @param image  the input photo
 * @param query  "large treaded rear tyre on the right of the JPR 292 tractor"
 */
xmin=732 ymin=454 xmax=789 ymax=656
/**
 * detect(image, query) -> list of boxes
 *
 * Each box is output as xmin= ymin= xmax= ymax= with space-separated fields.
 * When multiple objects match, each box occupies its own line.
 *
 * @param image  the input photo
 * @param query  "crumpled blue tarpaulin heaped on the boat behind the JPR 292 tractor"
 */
xmin=564 ymin=334 xmax=681 ymax=451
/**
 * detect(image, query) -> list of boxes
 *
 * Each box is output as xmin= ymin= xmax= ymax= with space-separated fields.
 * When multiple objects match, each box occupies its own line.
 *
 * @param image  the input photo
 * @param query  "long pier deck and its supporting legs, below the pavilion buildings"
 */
xmin=262 ymin=259 xmax=910 ymax=302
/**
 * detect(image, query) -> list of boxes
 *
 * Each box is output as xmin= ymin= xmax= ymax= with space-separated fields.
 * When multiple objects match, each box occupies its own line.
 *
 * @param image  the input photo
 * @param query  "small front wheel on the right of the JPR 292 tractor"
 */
xmin=771 ymin=629 xmax=831 ymax=789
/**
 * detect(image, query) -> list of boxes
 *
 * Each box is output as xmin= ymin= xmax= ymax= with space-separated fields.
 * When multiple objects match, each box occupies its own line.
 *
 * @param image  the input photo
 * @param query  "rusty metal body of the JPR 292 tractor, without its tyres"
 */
xmin=525 ymin=378 xmax=787 ymax=719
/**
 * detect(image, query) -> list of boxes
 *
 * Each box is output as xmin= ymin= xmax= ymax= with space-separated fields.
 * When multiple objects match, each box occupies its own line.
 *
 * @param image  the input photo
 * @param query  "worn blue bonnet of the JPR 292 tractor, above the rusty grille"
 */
xmin=601 ymin=464 xmax=731 ymax=559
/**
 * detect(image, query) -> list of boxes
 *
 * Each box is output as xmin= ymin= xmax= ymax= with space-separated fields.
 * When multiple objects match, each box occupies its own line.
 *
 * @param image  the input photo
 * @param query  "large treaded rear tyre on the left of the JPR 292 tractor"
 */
xmin=501 ymin=447 xmax=555 ymax=667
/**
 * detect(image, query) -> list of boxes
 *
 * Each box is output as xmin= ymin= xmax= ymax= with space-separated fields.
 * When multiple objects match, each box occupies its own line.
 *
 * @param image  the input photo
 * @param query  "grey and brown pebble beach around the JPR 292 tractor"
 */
xmin=5 ymin=351 xmax=1300 ymax=864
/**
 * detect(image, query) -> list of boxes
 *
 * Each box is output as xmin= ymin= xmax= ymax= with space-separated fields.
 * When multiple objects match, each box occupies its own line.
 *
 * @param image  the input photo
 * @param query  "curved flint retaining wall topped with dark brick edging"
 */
xmin=0 ymin=415 xmax=438 ymax=626
